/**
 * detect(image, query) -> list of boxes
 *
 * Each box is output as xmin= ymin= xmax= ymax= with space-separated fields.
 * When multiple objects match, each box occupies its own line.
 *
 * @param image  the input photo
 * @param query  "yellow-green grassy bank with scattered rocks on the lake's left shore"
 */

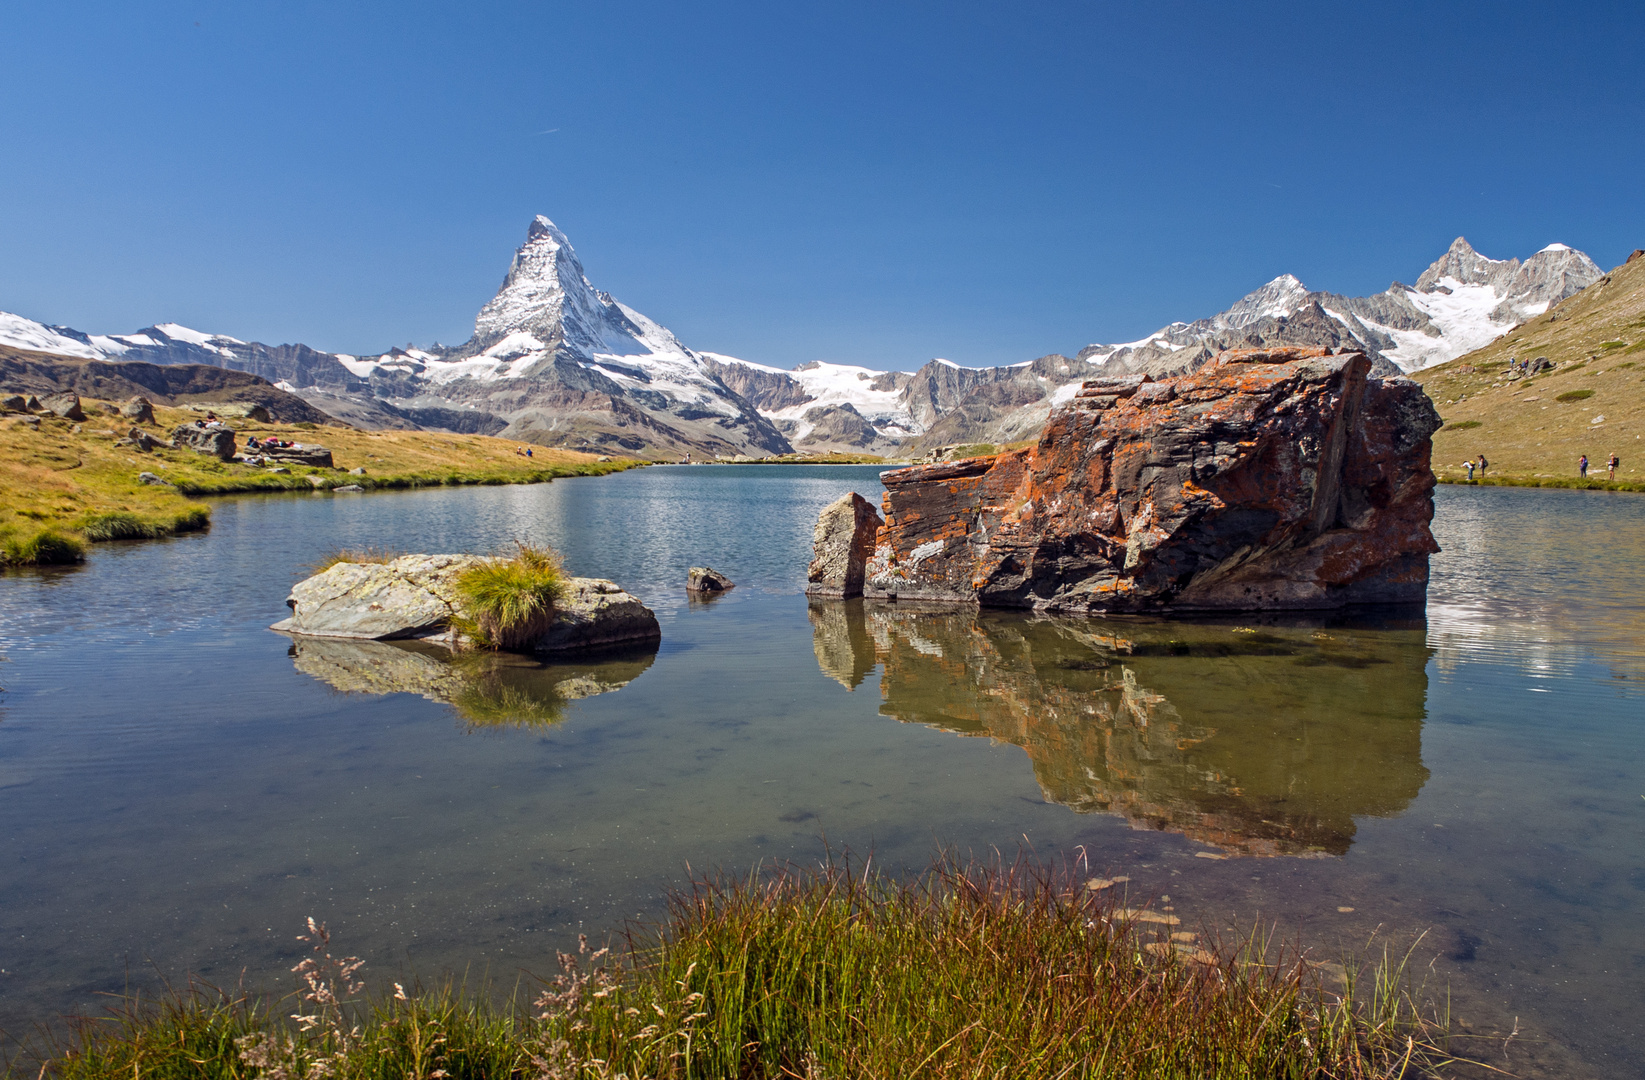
xmin=0 ymin=399 xmax=646 ymax=567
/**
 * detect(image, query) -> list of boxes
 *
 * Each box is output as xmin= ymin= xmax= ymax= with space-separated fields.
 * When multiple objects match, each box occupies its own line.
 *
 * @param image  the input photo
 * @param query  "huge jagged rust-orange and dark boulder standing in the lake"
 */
xmin=864 ymin=348 xmax=1439 ymax=613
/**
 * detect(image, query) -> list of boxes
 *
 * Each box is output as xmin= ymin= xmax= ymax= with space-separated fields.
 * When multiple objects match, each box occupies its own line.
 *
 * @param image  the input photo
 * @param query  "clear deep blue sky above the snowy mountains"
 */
xmin=0 ymin=0 xmax=1645 ymax=368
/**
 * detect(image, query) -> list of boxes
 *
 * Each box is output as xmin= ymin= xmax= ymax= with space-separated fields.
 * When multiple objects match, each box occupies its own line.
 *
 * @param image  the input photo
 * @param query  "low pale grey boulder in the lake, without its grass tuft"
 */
xmin=271 ymin=556 xmax=663 ymax=653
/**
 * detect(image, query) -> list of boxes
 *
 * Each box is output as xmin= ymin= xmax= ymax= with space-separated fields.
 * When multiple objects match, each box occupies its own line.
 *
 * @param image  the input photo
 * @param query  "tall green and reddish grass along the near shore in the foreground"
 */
xmin=10 ymin=863 xmax=1444 ymax=1080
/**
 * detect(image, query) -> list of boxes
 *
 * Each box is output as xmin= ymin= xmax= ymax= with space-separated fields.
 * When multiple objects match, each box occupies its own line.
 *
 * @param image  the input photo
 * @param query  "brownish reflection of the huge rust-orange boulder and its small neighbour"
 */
xmin=811 ymin=600 xmax=1428 ymax=856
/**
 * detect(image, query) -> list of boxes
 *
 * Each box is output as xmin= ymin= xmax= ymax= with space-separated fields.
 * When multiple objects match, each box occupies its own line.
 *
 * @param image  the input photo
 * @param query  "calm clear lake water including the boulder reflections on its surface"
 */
xmin=0 ymin=465 xmax=1645 ymax=1077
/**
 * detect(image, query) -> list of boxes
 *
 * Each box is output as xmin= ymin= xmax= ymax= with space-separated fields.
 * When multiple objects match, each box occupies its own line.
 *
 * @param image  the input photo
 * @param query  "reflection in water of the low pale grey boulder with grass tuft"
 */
xmin=291 ymin=638 xmax=656 ymax=727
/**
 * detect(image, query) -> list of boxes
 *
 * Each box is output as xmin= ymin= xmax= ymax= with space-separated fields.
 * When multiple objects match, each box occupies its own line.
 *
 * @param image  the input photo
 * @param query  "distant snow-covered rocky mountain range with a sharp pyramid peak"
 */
xmin=0 ymin=217 xmax=1601 ymax=457
